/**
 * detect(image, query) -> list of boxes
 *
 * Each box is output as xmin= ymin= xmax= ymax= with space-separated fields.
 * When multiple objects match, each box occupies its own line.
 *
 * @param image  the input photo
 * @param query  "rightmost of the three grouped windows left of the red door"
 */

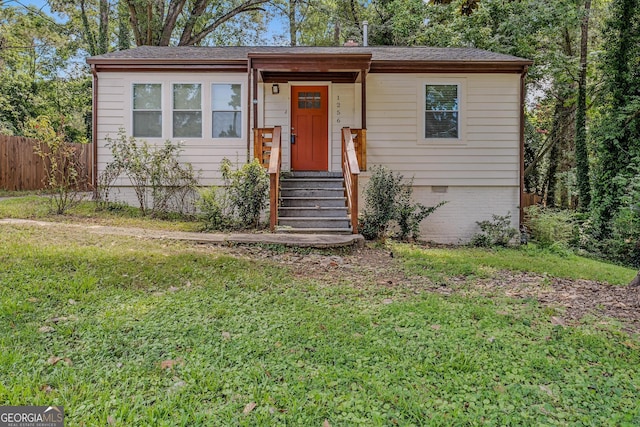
xmin=211 ymin=83 xmax=242 ymax=138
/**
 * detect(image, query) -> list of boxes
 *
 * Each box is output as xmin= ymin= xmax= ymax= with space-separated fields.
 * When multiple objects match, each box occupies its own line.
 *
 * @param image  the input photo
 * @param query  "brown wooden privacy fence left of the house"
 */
xmin=0 ymin=135 xmax=93 ymax=191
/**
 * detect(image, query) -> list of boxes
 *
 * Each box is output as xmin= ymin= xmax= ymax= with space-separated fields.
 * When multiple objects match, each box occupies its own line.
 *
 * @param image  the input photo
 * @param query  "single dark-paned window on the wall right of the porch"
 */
xmin=424 ymin=83 xmax=460 ymax=139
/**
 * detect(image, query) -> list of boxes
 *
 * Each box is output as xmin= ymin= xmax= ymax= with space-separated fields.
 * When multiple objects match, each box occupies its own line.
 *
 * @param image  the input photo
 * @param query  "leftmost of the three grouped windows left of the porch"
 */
xmin=133 ymin=83 xmax=162 ymax=138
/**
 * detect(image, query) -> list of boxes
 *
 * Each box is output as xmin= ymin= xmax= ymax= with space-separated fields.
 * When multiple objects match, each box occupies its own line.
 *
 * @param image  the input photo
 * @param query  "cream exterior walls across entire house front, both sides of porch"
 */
xmin=98 ymin=72 xmax=520 ymax=243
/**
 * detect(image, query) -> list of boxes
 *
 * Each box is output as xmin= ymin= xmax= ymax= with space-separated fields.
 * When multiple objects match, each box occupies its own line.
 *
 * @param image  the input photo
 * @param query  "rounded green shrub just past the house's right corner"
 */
xmin=526 ymin=206 xmax=575 ymax=248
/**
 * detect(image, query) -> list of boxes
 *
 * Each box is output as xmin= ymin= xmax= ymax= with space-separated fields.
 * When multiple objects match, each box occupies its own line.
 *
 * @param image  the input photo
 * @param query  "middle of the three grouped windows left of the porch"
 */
xmin=172 ymin=83 xmax=202 ymax=138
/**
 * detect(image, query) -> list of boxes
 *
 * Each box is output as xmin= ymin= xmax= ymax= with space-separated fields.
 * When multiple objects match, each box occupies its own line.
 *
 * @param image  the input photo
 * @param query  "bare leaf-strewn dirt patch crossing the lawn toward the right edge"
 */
xmin=231 ymin=246 xmax=640 ymax=333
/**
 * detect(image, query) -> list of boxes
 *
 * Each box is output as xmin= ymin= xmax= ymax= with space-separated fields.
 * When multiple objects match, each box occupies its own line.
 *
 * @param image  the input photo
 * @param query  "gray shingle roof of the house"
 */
xmin=87 ymin=46 xmax=531 ymax=65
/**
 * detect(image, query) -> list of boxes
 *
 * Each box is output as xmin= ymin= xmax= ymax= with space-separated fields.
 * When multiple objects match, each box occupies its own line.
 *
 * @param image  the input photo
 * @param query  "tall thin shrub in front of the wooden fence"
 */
xmin=25 ymin=116 xmax=82 ymax=215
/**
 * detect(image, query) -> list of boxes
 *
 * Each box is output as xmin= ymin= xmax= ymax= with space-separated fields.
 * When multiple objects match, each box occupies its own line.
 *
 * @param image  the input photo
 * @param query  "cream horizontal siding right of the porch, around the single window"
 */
xmin=367 ymin=74 xmax=520 ymax=187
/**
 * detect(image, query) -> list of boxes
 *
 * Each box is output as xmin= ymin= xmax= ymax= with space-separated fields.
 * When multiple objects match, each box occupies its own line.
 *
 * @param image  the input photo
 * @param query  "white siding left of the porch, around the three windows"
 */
xmin=97 ymin=72 xmax=249 ymax=206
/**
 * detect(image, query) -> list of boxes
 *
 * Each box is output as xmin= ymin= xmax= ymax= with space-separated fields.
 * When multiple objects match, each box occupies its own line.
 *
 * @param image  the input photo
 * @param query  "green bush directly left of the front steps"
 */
xmin=198 ymin=159 xmax=269 ymax=230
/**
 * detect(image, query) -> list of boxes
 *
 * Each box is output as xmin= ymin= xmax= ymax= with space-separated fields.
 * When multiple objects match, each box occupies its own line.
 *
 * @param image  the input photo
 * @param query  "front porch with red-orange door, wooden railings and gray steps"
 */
xmin=249 ymin=49 xmax=371 ymax=234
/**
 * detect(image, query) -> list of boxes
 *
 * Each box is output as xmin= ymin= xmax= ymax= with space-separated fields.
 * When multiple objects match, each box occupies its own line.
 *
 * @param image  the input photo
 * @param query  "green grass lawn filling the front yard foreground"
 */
xmin=0 ymin=219 xmax=640 ymax=426
